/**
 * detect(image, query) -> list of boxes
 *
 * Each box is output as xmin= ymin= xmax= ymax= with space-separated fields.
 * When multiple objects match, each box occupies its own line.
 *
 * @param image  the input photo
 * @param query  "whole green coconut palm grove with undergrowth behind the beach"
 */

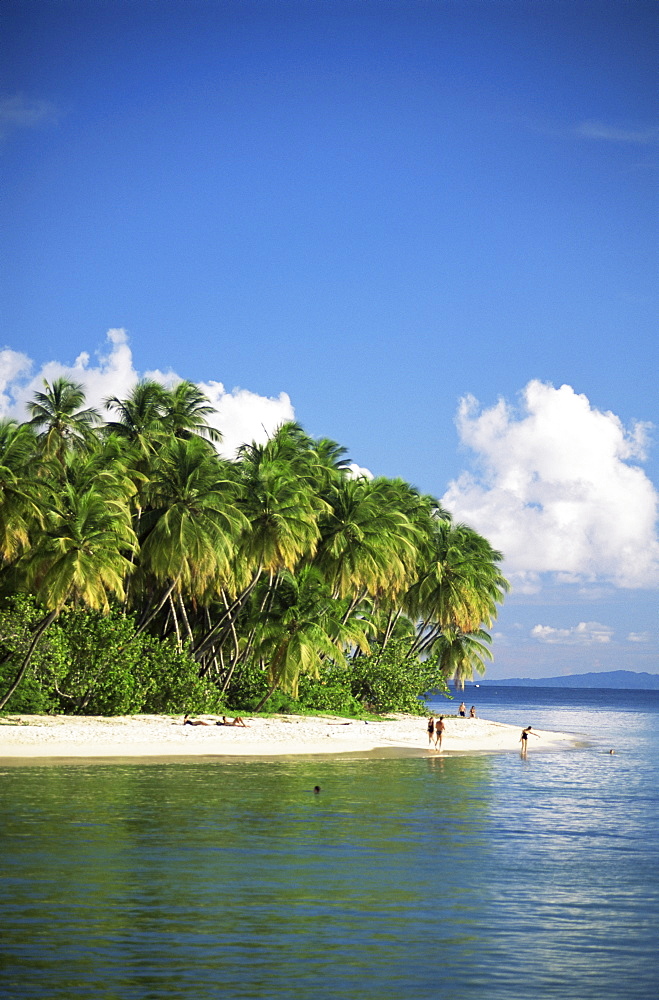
xmin=0 ymin=378 xmax=508 ymax=715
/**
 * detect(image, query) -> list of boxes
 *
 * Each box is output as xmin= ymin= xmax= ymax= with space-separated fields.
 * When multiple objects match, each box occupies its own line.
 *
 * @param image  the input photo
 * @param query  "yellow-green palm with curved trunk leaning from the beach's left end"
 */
xmin=0 ymin=484 xmax=137 ymax=710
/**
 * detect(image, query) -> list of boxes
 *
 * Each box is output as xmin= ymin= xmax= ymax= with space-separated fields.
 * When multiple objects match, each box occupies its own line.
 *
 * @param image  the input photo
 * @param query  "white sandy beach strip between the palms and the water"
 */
xmin=0 ymin=715 xmax=576 ymax=760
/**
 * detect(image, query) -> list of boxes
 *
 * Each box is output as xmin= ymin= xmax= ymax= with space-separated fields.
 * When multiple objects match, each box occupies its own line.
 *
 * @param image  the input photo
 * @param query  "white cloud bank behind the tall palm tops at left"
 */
xmin=0 ymin=329 xmax=295 ymax=457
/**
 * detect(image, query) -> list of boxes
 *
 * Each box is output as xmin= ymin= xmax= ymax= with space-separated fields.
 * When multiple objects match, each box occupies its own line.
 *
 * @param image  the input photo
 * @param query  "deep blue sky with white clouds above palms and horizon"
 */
xmin=0 ymin=0 xmax=659 ymax=677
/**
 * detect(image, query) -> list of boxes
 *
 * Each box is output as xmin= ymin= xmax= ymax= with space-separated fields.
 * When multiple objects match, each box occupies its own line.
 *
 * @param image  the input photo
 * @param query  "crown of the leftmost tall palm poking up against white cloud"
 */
xmin=27 ymin=377 xmax=101 ymax=462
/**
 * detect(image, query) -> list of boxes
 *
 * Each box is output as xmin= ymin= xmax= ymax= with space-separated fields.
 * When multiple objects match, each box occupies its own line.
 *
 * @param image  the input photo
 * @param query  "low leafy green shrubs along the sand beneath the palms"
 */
xmin=0 ymin=596 xmax=448 ymax=717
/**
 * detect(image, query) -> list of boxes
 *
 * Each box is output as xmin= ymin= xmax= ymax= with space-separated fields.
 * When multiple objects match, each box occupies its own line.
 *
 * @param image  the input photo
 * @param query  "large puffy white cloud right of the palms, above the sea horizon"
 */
xmin=443 ymin=381 xmax=659 ymax=590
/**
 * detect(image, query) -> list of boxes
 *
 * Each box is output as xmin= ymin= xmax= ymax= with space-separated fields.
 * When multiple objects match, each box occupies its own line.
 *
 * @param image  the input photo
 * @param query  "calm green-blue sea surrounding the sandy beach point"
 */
xmin=0 ymin=687 xmax=659 ymax=1000
